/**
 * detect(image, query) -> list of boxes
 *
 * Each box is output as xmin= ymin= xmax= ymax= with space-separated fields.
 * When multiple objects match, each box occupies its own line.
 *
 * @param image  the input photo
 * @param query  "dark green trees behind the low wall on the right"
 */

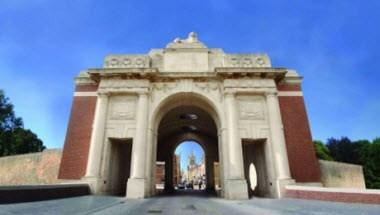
xmin=314 ymin=137 xmax=380 ymax=189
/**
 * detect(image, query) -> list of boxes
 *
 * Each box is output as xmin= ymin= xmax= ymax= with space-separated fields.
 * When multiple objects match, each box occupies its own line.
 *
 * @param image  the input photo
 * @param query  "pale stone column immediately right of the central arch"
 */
xmin=224 ymin=92 xmax=248 ymax=199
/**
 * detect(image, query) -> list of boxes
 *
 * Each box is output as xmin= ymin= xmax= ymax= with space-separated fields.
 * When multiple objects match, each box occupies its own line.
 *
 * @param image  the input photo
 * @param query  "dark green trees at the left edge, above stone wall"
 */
xmin=0 ymin=90 xmax=45 ymax=156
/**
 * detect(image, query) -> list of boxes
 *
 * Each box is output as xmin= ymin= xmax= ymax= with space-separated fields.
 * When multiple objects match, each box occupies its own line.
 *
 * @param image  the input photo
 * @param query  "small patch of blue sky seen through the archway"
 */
xmin=174 ymin=141 xmax=204 ymax=171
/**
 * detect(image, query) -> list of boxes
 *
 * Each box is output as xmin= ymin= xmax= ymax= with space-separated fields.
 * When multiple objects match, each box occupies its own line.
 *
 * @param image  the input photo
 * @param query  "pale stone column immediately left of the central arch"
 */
xmin=127 ymin=92 xmax=148 ymax=198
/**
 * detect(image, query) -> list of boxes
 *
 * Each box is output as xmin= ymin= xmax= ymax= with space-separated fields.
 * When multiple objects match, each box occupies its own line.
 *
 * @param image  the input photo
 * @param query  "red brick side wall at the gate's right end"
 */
xmin=278 ymin=85 xmax=321 ymax=182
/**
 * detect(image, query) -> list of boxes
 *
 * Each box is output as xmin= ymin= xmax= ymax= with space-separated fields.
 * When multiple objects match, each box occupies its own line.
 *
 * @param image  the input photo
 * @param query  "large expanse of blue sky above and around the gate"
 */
xmin=0 ymin=0 xmax=380 ymax=148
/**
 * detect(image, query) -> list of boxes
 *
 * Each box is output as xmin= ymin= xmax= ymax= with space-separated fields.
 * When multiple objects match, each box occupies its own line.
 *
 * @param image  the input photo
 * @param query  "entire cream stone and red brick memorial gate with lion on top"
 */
xmin=59 ymin=33 xmax=320 ymax=199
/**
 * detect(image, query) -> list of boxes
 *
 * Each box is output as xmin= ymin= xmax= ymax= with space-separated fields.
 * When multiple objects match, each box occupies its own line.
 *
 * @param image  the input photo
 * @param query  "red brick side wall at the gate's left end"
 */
xmin=58 ymin=85 xmax=97 ymax=179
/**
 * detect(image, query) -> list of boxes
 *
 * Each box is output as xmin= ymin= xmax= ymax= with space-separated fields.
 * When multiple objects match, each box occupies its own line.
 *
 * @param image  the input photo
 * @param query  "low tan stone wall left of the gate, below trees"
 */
xmin=0 ymin=149 xmax=62 ymax=185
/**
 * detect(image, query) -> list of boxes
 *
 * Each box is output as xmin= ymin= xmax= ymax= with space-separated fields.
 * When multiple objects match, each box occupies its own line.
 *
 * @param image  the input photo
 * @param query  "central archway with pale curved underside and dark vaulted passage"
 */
xmin=148 ymin=93 xmax=223 ymax=197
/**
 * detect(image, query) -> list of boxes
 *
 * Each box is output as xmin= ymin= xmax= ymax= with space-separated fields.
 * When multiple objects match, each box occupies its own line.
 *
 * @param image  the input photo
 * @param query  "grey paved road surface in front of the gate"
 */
xmin=0 ymin=191 xmax=380 ymax=215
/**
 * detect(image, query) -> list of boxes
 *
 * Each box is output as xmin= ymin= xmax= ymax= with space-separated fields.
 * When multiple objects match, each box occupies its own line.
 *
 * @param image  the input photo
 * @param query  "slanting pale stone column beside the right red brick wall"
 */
xmin=266 ymin=92 xmax=293 ymax=197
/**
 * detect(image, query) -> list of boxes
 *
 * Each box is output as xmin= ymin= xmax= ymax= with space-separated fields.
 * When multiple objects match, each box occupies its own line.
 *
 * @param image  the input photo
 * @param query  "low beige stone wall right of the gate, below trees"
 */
xmin=319 ymin=160 xmax=365 ymax=189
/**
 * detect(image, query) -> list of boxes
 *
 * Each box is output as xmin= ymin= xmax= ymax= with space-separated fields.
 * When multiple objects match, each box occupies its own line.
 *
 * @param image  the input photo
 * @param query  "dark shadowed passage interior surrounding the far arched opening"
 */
xmin=154 ymin=102 xmax=221 ymax=196
